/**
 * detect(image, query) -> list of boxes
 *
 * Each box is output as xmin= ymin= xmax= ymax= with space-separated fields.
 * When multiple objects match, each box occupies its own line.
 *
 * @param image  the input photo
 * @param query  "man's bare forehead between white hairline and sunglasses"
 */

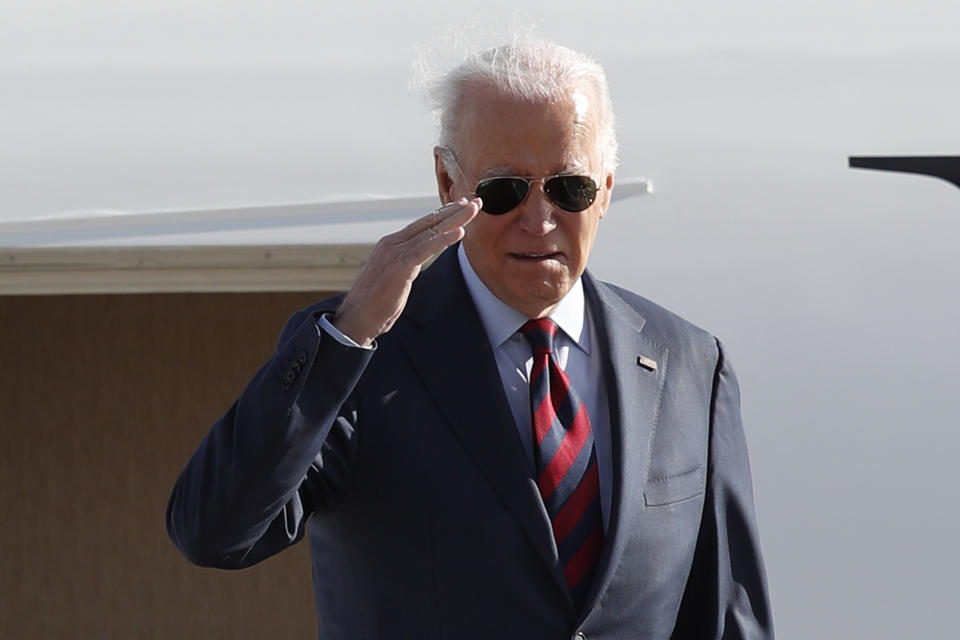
xmin=459 ymin=79 xmax=599 ymax=177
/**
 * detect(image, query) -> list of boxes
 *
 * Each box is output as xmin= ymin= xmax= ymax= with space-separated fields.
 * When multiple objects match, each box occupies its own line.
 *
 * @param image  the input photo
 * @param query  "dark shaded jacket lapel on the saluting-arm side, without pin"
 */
xmin=402 ymin=247 xmax=569 ymax=599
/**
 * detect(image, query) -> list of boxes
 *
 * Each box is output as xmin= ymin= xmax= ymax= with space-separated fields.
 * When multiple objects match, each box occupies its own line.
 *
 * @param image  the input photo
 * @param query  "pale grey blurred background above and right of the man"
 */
xmin=0 ymin=0 xmax=960 ymax=639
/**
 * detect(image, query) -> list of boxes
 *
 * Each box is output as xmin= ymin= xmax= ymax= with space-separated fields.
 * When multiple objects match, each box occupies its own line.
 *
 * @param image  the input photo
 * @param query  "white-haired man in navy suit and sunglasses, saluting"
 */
xmin=167 ymin=43 xmax=772 ymax=640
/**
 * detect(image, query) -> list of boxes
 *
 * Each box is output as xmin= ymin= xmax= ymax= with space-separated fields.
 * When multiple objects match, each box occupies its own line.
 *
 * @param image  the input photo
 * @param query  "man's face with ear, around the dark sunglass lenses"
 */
xmin=437 ymin=80 xmax=613 ymax=318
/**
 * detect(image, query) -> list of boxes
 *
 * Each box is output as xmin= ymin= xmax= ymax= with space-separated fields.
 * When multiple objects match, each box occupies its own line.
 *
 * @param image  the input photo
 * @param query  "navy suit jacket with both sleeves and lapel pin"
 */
xmin=167 ymin=247 xmax=773 ymax=640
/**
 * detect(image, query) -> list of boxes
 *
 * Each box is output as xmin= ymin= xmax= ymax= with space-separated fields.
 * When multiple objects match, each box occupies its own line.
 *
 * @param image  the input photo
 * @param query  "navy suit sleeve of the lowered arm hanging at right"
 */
xmin=673 ymin=341 xmax=773 ymax=640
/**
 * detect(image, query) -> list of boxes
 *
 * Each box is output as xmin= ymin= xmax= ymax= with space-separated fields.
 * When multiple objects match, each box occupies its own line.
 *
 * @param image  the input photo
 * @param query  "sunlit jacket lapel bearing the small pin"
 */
xmin=583 ymin=274 xmax=668 ymax=615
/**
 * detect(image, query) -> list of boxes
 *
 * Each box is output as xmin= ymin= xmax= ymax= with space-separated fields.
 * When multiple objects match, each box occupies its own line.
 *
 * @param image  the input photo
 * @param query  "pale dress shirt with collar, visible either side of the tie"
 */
xmin=457 ymin=245 xmax=613 ymax=530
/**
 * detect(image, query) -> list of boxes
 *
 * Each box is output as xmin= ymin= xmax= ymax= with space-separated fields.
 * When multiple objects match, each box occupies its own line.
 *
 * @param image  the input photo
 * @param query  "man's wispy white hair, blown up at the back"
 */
xmin=419 ymin=38 xmax=617 ymax=171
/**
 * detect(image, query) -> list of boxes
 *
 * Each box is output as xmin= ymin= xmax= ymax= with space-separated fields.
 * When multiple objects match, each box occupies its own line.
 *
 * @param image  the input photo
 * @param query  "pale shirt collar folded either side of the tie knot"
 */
xmin=457 ymin=244 xmax=590 ymax=355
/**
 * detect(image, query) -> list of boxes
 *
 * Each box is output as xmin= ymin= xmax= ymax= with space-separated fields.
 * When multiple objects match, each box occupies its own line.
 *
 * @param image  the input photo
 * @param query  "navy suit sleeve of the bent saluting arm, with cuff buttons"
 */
xmin=166 ymin=301 xmax=372 ymax=569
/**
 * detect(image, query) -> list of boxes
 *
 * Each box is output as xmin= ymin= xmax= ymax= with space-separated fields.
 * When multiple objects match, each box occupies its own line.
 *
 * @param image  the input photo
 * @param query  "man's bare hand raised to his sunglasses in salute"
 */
xmin=331 ymin=198 xmax=481 ymax=346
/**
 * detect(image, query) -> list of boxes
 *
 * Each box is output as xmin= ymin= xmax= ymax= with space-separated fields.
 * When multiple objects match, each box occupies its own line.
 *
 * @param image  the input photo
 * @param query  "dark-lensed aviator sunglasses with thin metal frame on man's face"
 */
xmin=444 ymin=149 xmax=599 ymax=216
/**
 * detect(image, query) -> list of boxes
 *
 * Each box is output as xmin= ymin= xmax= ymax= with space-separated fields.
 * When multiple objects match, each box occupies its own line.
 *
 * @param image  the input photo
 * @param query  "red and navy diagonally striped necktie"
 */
xmin=520 ymin=318 xmax=603 ymax=607
